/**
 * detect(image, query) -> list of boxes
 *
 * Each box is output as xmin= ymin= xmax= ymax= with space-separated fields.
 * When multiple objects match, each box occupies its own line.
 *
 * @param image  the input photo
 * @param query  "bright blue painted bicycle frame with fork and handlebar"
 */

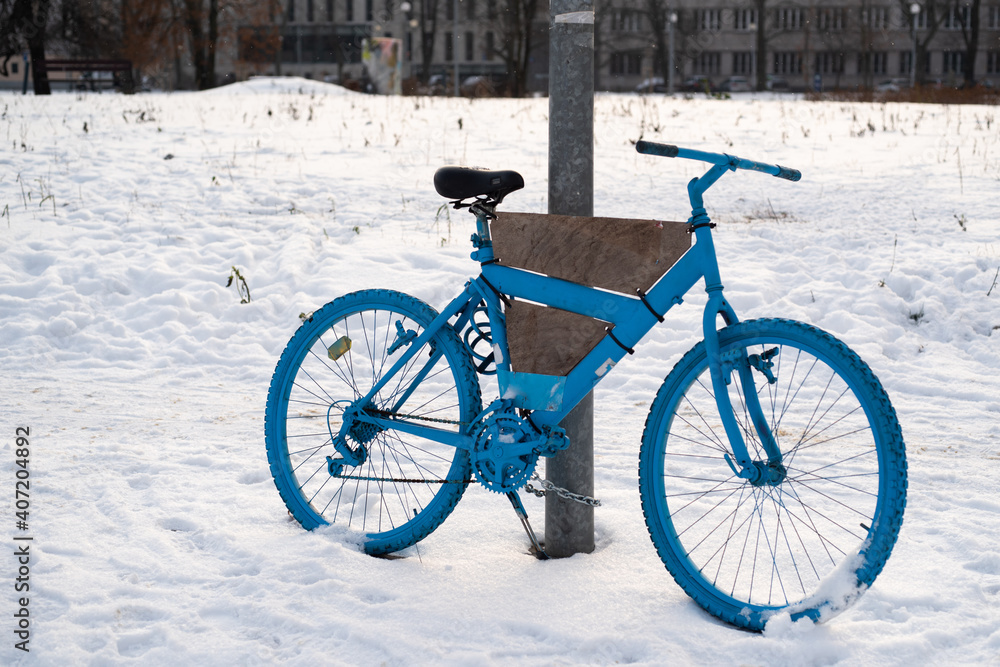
xmin=334 ymin=142 xmax=799 ymax=484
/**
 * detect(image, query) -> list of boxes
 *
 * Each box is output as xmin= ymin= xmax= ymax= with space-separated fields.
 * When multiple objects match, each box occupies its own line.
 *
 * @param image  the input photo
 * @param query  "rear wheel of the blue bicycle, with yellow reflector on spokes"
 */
xmin=264 ymin=290 xmax=482 ymax=555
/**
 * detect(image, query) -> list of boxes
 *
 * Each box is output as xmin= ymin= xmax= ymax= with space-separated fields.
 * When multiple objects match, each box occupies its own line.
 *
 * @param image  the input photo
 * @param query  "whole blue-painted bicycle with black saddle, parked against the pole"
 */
xmin=265 ymin=141 xmax=907 ymax=630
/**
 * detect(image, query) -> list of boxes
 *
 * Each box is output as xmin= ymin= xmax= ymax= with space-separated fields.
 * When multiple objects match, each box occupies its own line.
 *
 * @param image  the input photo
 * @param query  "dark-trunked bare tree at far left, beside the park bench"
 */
xmin=0 ymin=0 xmax=52 ymax=95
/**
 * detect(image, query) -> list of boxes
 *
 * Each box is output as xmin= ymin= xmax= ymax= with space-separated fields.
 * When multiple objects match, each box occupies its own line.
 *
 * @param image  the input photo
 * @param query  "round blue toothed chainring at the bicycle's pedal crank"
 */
xmin=472 ymin=413 xmax=538 ymax=493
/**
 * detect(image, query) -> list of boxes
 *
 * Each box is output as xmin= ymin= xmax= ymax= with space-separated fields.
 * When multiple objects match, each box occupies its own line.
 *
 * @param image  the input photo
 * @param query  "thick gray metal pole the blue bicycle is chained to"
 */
xmin=545 ymin=0 xmax=594 ymax=558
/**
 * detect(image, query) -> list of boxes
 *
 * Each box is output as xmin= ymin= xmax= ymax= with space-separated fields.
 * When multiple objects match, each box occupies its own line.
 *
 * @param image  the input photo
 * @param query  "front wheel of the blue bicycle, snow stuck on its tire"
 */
xmin=639 ymin=320 xmax=906 ymax=630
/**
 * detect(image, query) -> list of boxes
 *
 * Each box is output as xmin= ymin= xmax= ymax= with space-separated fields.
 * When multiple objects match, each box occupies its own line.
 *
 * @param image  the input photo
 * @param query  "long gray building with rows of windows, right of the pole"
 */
xmin=597 ymin=0 xmax=1000 ymax=91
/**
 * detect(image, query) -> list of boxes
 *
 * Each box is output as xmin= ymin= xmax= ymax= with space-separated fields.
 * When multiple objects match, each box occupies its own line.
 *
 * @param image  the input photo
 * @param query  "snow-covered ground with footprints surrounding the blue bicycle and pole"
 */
xmin=0 ymin=80 xmax=1000 ymax=665
